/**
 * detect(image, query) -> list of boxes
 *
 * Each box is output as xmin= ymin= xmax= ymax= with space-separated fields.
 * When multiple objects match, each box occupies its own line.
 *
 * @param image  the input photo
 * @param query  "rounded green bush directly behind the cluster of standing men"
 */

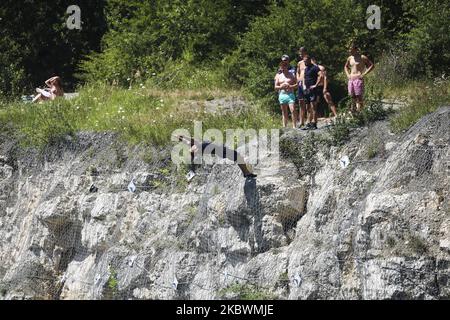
xmin=227 ymin=0 xmax=365 ymax=97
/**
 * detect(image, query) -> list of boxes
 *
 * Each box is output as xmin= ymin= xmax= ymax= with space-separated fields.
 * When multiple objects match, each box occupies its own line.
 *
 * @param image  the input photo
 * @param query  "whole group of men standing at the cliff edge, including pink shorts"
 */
xmin=275 ymin=44 xmax=374 ymax=130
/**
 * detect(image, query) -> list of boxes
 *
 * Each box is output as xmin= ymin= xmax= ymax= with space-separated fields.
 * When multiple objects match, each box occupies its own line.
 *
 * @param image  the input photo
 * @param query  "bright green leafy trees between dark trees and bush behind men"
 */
xmin=78 ymin=0 xmax=267 ymax=85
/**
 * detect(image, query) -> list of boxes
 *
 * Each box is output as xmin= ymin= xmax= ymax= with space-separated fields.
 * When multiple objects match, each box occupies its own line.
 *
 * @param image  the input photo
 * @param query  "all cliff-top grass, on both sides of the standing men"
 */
xmin=0 ymin=65 xmax=450 ymax=146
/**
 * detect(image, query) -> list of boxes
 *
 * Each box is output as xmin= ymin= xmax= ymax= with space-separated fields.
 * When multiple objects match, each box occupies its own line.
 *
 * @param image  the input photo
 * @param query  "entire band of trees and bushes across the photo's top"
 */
xmin=0 ymin=0 xmax=450 ymax=97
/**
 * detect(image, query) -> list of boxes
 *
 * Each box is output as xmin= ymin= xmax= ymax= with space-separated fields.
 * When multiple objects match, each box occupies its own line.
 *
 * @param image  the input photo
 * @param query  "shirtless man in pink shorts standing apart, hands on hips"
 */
xmin=344 ymin=44 xmax=375 ymax=113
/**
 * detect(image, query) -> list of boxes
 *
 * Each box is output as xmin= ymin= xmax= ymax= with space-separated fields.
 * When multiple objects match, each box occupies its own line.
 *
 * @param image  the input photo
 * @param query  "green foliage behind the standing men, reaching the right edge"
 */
xmin=228 ymin=0 xmax=450 ymax=98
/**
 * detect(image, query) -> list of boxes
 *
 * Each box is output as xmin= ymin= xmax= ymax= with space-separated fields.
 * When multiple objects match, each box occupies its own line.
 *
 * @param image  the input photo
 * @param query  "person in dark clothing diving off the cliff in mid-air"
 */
xmin=176 ymin=135 xmax=257 ymax=178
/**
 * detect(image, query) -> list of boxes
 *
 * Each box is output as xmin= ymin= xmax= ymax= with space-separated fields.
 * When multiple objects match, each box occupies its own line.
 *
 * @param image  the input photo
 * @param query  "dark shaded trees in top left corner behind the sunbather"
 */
xmin=0 ymin=0 xmax=106 ymax=96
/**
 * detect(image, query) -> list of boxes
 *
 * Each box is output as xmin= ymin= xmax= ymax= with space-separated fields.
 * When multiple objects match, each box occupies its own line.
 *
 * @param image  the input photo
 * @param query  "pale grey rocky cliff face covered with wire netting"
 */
xmin=0 ymin=108 xmax=450 ymax=299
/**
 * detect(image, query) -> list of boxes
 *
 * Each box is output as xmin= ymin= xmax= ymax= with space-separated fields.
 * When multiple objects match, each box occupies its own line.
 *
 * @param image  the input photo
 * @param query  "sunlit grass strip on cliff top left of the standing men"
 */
xmin=0 ymin=85 xmax=279 ymax=145
